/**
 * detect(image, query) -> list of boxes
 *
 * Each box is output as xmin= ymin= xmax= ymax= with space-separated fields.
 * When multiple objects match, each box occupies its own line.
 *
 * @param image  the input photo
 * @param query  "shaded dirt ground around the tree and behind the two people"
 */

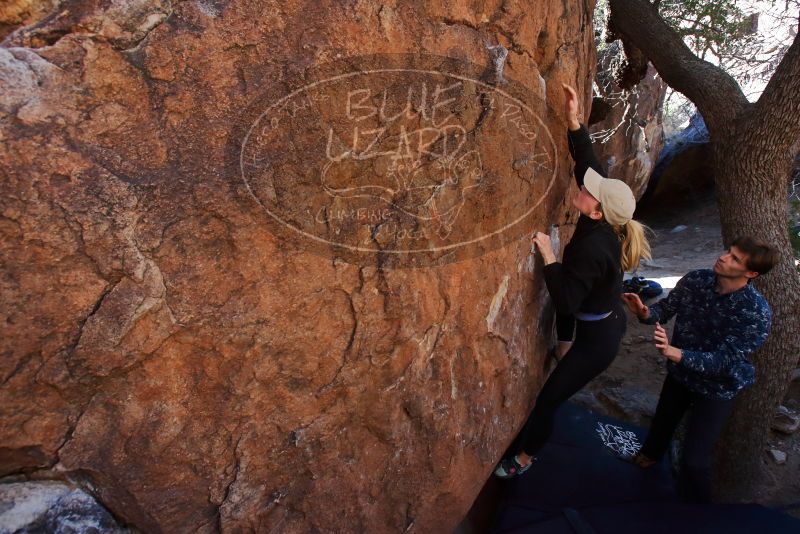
xmin=580 ymin=200 xmax=800 ymax=517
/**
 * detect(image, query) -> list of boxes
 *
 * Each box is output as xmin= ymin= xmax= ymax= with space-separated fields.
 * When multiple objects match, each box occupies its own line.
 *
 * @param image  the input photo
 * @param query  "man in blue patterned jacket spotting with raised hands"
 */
xmin=622 ymin=237 xmax=778 ymax=503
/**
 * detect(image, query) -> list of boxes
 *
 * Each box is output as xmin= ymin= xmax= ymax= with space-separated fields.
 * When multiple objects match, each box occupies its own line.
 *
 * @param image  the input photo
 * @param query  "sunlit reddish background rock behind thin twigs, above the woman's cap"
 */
xmin=589 ymin=42 xmax=667 ymax=198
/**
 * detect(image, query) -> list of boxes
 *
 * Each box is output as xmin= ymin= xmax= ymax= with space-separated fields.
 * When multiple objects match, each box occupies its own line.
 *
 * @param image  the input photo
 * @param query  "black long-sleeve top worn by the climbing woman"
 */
xmin=544 ymin=126 xmax=622 ymax=341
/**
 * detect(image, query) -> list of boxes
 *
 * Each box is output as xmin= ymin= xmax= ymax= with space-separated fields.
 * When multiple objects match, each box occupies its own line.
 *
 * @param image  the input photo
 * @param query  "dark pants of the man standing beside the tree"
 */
xmin=641 ymin=375 xmax=733 ymax=503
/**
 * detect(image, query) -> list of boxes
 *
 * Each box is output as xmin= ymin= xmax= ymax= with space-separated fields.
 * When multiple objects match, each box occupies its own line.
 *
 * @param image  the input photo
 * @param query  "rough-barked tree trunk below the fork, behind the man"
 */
xmin=714 ymin=119 xmax=800 ymax=500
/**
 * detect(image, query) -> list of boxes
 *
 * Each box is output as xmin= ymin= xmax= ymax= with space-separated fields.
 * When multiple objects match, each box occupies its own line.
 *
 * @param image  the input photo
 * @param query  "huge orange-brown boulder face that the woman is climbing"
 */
xmin=0 ymin=0 xmax=595 ymax=532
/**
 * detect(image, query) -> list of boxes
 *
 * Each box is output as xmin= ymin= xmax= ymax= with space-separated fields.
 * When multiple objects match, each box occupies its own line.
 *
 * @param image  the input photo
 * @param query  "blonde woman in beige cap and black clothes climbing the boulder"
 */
xmin=495 ymin=85 xmax=650 ymax=478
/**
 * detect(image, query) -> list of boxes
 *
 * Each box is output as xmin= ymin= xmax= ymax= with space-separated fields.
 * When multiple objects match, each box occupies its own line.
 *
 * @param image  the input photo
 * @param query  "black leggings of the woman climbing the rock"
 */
xmin=514 ymin=303 xmax=627 ymax=456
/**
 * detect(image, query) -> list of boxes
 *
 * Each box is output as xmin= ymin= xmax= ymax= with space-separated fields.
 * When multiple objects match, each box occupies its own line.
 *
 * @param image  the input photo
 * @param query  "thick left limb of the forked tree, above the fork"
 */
xmin=609 ymin=0 xmax=749 ymax=136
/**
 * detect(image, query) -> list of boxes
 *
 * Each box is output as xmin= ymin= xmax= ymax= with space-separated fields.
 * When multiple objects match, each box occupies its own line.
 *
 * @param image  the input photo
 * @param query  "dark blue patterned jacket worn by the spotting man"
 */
xmin=641 ymin=269 xmax=772 ymax=399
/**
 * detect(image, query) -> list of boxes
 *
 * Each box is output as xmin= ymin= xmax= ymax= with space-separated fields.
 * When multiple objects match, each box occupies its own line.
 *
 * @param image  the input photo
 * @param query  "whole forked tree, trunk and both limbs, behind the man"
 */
xmin=610 ymin=0 xmax=800 ymax=500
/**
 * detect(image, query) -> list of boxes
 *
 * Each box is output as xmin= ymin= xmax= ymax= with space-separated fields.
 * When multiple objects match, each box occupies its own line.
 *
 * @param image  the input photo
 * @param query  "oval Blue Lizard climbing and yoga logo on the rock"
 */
xmin=240 ymin=57 xmax=557 ymax=266
